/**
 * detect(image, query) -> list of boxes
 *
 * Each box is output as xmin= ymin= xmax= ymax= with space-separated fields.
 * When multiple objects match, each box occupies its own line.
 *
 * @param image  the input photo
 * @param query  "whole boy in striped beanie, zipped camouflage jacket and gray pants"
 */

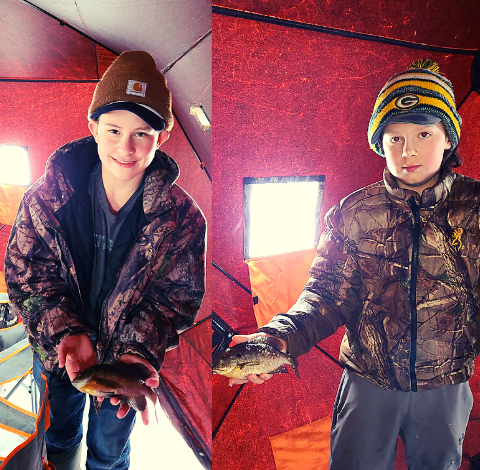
xmin=230 ymin=60 xmax=480 ymax=470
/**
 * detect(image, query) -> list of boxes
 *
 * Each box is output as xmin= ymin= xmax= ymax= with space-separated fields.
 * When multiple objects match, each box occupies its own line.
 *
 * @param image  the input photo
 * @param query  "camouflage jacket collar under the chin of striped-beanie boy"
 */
xmin=383 ymin=167 xmax=455 ymax=208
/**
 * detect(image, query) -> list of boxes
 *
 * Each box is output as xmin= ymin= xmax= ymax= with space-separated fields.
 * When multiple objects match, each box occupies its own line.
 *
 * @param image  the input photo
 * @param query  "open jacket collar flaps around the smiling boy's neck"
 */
xmin=38 ymin=136 xmax=180 ymax=220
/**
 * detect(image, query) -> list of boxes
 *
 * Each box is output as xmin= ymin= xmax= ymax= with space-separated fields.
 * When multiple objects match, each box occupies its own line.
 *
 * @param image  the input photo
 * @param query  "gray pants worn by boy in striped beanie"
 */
xmin=329 ymin=369 xmax=473 ymax=470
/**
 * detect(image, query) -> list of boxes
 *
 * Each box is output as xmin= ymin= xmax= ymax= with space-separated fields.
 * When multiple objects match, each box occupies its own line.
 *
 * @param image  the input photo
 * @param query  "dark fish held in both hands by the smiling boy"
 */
xmin=72 ymin=361 xmax=157 ymax=412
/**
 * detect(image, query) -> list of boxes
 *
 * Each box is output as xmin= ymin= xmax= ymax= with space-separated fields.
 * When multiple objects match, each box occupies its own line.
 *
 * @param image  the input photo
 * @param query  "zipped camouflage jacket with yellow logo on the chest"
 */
xmin=260 ymin=169 xmax=480 ymax=391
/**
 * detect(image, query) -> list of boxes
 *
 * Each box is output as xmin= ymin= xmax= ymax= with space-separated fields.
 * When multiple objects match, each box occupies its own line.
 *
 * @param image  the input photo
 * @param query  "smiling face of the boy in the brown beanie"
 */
xmin=88 ymin=110 xmax=168 ymax=187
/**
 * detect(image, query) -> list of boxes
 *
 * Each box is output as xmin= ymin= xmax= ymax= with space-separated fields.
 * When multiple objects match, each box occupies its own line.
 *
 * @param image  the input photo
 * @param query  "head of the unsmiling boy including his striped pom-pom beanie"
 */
xmin=368 ymin=60 xmax=462 ymax=194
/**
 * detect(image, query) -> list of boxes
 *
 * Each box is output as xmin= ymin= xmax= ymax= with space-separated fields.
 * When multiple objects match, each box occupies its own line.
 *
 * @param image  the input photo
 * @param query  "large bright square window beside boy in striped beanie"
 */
xmin=243 ymin=175 xmax=325 ymax=259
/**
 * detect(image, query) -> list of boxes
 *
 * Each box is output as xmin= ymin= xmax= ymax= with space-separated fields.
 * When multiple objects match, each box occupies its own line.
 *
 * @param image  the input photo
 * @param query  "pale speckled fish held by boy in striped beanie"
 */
xmin=213 ymin=336 xmax=300 ymax=379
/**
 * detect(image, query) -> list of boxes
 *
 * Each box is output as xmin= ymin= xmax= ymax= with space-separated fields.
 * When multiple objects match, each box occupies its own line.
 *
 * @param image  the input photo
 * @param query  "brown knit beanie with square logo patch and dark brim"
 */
xmin=88 ymin=51 xmax=173 ymax=131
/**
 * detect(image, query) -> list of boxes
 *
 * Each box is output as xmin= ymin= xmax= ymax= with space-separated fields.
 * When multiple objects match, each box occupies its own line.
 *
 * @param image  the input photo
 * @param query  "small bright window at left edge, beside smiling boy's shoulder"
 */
xmin=0 ymin=145 xmax=31 ymax=186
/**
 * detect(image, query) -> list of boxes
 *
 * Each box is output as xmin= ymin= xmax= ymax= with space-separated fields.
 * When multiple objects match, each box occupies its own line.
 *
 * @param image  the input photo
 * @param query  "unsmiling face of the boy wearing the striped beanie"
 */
xmin=382 ymin=122 xmax=451 ymax=194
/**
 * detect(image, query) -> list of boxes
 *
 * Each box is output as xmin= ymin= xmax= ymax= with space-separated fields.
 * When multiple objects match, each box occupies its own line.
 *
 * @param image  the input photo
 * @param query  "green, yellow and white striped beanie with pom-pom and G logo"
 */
xmin=368 ymin=59 xmax=462 ymax=157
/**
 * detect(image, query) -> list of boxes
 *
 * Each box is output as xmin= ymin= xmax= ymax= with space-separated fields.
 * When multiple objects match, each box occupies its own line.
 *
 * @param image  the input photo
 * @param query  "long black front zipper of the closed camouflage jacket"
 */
xmin=407 ymin=196 xmax=420 ymax=392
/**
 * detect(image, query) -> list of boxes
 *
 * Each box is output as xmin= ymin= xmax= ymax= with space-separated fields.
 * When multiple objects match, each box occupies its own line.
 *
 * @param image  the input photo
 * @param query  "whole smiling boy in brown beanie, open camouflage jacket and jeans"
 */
xmin=5 ymin=52 xmax=205 ymax=470
